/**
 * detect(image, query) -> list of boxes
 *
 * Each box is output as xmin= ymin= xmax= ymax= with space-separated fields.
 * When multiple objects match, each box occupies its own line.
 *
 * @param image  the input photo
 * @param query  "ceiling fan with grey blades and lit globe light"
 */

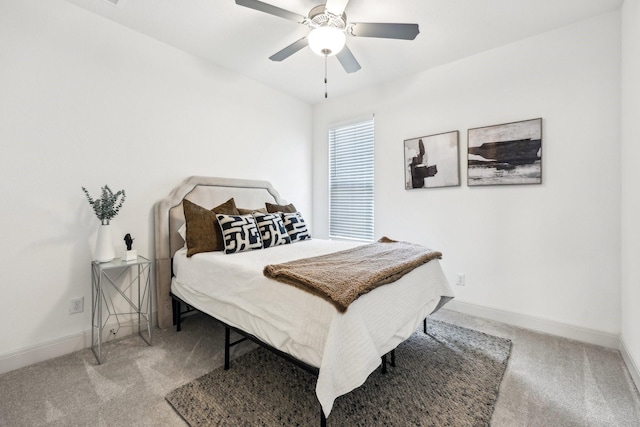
xmin=236 ymin=0 xmax=420 ymax=73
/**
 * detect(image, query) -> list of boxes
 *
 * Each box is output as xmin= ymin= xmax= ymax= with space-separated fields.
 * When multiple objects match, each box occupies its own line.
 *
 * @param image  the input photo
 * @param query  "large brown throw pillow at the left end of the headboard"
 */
xmin=182 ymin=198 xmax=239 ymax=257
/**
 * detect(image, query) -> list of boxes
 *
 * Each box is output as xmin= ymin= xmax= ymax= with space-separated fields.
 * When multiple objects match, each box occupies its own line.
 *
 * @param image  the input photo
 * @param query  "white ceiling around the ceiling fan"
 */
xmin=68 ymin=0 xmax=623 ymax=104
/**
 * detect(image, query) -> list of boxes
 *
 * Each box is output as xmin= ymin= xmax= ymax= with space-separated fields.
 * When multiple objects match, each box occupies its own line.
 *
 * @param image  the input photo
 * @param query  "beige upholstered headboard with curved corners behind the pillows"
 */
xmin=154 ymin=176 xmax=287 ymax=328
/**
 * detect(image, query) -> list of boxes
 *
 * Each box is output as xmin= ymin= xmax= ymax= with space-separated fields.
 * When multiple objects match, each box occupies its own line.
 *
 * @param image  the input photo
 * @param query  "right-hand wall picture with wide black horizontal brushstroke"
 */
xmin=467 ymin=118 xmax=542 ymax=186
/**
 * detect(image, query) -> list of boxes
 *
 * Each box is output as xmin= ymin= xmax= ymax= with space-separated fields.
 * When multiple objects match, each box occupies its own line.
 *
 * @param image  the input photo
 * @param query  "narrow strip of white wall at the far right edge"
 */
xmin=621 ymin=0 xmax=640 ymax=385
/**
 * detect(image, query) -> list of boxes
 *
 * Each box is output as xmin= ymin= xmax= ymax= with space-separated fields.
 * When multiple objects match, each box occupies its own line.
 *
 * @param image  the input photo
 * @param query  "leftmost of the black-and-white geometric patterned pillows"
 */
xmin=216 ymin=214 xmax=262 ymax=254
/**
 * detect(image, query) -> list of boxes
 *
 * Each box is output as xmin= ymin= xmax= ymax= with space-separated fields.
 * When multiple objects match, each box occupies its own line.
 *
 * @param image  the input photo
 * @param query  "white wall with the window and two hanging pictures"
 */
xmin=313 ymin=12 xmax=624 ymax=339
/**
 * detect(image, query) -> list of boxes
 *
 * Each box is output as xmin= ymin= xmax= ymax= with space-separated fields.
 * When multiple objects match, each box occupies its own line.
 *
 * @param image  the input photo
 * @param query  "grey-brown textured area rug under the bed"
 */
xmin=166 ymin=319 xmax=511 ymax=427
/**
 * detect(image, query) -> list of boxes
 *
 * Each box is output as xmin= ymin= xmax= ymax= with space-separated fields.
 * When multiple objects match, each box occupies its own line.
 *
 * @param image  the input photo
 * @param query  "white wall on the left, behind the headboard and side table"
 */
xmin=0 ymin=0 xmax=312 ymax=372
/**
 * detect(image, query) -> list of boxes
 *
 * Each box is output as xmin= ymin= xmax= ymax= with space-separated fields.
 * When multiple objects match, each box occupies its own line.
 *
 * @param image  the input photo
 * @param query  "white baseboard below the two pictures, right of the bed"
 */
xmin=445 ymin=300 xmax=620 ymax=350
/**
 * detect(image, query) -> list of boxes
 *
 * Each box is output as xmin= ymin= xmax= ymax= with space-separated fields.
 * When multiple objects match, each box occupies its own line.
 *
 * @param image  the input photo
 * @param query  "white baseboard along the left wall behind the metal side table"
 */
xmin=0 ymin=322 xmax=148 ymax=374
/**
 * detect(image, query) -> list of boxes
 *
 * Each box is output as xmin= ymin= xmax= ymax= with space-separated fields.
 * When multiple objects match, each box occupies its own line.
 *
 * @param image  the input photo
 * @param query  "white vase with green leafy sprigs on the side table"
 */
xmin=82 ymin=185 xmax=126 ymax=262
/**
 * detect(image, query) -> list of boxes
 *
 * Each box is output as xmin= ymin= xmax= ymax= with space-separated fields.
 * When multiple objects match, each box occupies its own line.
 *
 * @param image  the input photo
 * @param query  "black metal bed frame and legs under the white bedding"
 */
xmin=170 ymin=294 xmax=427 ymax=427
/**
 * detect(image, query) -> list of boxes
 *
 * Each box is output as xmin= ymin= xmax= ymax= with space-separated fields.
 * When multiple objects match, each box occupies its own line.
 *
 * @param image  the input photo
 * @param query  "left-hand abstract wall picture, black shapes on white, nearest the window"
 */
xmin=404 ymin=130 xmax=460 ymax=190
